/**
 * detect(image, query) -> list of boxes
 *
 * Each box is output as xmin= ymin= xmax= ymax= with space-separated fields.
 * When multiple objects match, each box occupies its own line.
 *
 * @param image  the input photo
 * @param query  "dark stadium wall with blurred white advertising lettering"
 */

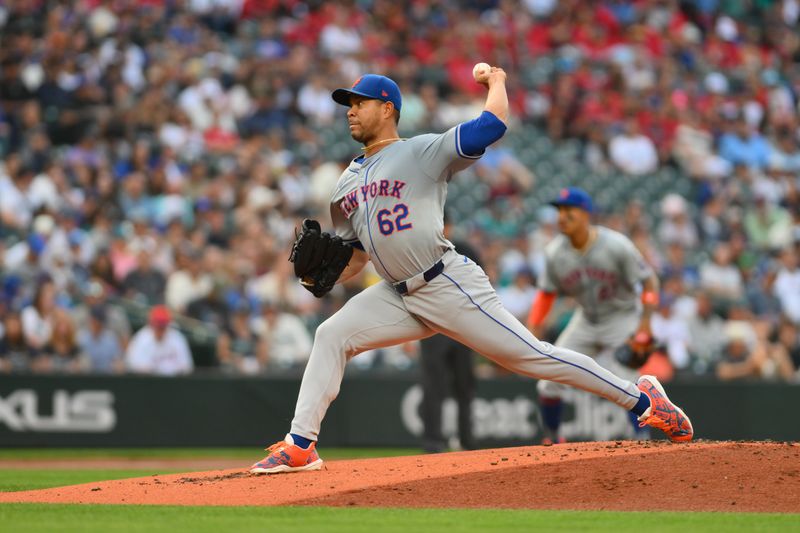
xmin=0 ymin=375 xmax=800 ymax=447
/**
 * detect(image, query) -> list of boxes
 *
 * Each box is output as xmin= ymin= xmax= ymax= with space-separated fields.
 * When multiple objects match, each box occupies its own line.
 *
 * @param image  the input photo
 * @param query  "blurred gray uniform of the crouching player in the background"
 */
xmin=537 ymin=226 xmax=653 ymax=398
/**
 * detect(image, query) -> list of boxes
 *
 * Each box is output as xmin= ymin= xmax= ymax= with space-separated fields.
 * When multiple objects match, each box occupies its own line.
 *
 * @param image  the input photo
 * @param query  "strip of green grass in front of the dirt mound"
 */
xmin=0 ymin=504 xmax=800 ymax=533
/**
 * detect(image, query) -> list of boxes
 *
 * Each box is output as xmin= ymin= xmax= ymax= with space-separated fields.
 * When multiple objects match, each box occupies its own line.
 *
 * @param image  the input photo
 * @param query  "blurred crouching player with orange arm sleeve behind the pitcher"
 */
xmin=528 ymin=187 xmax=658 ymax=444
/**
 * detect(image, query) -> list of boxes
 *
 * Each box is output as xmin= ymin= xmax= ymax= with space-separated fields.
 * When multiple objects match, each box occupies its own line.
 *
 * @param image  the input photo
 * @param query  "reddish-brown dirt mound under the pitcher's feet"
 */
xmin=0 ymin=442 xmax=800 ymax=512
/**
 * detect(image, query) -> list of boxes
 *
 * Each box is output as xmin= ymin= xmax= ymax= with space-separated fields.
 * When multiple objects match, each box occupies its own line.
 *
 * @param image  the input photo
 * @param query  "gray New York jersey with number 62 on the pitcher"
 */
xmin=331 ymin=128 xmax=477 ymax=282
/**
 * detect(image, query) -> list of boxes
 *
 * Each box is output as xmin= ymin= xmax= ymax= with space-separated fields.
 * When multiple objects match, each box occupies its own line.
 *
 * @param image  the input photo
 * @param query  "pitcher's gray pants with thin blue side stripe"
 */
xmin=291 ymin=250 xmax=640 ymax=440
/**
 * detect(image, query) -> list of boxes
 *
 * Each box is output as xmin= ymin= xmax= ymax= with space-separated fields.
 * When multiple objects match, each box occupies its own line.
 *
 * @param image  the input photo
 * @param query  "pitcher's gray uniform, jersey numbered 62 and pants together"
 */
xmin=291 ymin=126 xmax=640 ymax=440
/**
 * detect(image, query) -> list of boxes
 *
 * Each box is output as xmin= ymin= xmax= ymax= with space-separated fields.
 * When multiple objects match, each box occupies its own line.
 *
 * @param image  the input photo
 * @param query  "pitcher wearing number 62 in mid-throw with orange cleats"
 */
xmin=250 ymin=65 xmax=693 ymax=473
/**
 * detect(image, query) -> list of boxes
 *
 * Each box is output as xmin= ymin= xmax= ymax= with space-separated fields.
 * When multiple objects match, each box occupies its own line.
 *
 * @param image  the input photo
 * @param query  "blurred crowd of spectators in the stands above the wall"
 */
xmin=0 ymin=0 xmax=800 ymax=380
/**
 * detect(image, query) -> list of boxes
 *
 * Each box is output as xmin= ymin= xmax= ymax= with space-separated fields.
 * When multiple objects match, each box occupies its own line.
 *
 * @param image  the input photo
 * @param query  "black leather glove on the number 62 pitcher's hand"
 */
xmin=289 ymin=218 xmax=353 ymax=298
